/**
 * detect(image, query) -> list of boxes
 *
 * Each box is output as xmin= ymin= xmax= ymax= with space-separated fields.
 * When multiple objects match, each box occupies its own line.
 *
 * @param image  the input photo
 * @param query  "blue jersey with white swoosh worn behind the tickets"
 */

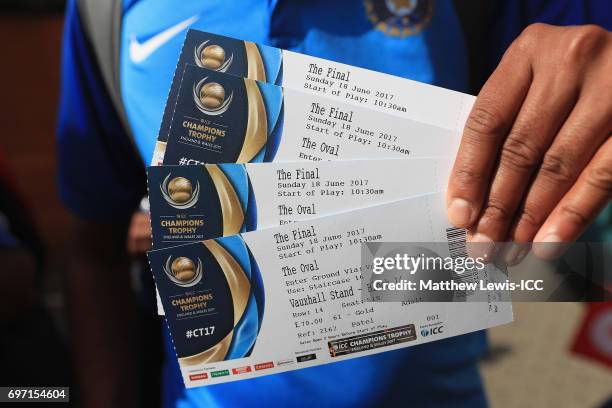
xmin=58 ymin=0 xmax=606 ymax=407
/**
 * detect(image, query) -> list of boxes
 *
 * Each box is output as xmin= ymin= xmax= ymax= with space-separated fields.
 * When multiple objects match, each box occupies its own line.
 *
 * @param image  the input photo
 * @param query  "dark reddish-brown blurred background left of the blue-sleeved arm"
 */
xmin=0 ymin=0 xmax=71 ymax=386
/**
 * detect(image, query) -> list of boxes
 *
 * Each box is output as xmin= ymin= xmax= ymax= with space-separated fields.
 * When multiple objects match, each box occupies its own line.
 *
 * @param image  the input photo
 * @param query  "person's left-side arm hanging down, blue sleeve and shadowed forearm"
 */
xmin=58 ymin=1 xmax=146 ymax=407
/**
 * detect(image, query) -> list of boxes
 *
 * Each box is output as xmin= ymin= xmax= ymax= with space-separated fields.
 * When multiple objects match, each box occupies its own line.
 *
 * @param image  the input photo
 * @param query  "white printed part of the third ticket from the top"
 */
xmin=246 ymin=158 xmax=453 ymax=228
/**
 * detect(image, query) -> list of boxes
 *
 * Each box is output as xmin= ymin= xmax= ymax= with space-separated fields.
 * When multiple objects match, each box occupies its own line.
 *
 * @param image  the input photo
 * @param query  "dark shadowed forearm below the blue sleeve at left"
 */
xmin=65 ymin=218 xmax=139 ymax=407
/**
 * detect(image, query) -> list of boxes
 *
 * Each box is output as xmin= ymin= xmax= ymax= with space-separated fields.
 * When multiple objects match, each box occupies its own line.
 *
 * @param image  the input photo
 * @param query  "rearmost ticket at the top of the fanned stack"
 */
xmin=159 ymin=30 xmax=475 ymax=150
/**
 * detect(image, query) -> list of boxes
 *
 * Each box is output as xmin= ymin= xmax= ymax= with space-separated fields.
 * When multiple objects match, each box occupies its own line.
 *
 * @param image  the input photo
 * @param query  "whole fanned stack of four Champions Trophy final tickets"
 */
xmin=148 ymin=30 xmax=512 ymax=387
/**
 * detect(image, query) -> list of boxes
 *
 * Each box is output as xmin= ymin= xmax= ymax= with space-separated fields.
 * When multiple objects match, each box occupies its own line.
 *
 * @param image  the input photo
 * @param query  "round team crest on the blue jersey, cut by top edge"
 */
xmin=364 ymin=0 xmax=433 ymax=38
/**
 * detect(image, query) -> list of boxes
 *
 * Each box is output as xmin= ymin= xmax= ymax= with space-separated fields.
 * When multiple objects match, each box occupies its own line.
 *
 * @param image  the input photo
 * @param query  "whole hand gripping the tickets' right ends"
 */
xmin=447 ymin=24 xmax=612 ymax=263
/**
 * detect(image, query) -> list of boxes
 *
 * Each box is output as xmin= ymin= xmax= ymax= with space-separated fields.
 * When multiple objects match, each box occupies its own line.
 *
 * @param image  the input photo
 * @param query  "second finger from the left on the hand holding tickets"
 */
xmin=472 ymin=70 xmax=577 ymax=243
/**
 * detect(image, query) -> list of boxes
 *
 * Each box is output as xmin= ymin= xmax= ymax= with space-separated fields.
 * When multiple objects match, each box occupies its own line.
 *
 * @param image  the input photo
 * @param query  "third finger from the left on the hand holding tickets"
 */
xmin=511 ymin=97 xmax=612 ymax=242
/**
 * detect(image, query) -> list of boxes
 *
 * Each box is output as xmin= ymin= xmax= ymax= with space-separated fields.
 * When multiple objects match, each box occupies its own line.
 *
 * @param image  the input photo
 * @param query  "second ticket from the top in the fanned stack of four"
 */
xmin=152 ymin=65 xmax=460 ymax=165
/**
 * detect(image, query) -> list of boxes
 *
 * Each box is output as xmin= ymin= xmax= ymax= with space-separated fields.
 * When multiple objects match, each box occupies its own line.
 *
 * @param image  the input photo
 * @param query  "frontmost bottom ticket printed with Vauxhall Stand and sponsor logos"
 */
xmin=148 ymin=193 xmax=512 ymax=387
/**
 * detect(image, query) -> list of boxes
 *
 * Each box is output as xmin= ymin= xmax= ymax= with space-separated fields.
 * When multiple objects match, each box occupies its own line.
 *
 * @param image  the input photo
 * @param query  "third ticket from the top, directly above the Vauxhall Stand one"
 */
xmin=147 ymin=158 xmax=452 ymax=248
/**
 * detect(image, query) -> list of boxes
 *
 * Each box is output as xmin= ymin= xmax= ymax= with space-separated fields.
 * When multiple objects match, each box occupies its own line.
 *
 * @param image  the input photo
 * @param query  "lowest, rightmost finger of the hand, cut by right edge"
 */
xmin=533 ymin=133 xmax=612 ymax=259
